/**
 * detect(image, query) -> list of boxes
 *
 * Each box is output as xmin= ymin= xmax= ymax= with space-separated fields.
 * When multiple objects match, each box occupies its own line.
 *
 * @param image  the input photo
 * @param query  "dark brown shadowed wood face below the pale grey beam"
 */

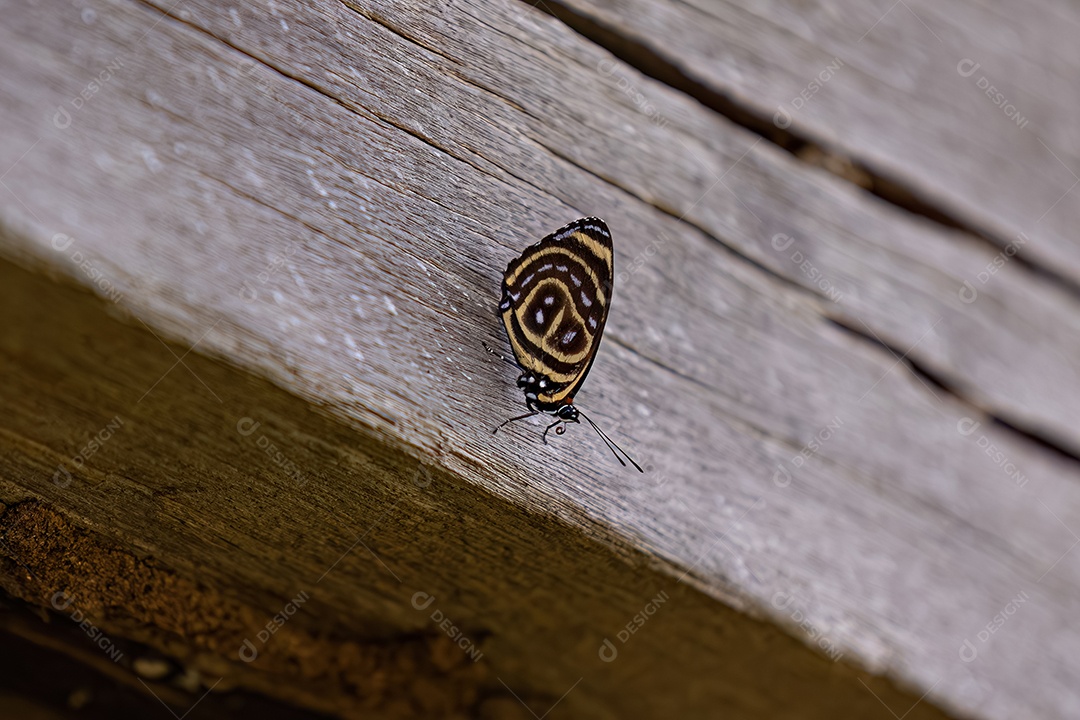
xmin=0 ymin=255 xmax=944 ymax=720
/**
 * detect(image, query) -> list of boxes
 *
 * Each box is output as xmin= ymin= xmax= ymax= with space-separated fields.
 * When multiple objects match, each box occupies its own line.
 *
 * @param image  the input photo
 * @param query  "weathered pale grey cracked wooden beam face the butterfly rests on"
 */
xmin=0 ymin=0 xmax=1080 ymax=718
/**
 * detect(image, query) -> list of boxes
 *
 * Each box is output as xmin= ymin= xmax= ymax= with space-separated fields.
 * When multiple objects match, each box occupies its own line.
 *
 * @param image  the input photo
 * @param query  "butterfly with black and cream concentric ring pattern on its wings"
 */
xmin=485 ymin=217 xmax=645 ymax=473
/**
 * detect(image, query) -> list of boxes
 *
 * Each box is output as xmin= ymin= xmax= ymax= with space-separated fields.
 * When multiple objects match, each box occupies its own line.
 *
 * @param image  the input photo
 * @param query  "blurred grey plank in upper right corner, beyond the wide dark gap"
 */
xmin=549 ymin=0 xmax=1080 ymax=282
